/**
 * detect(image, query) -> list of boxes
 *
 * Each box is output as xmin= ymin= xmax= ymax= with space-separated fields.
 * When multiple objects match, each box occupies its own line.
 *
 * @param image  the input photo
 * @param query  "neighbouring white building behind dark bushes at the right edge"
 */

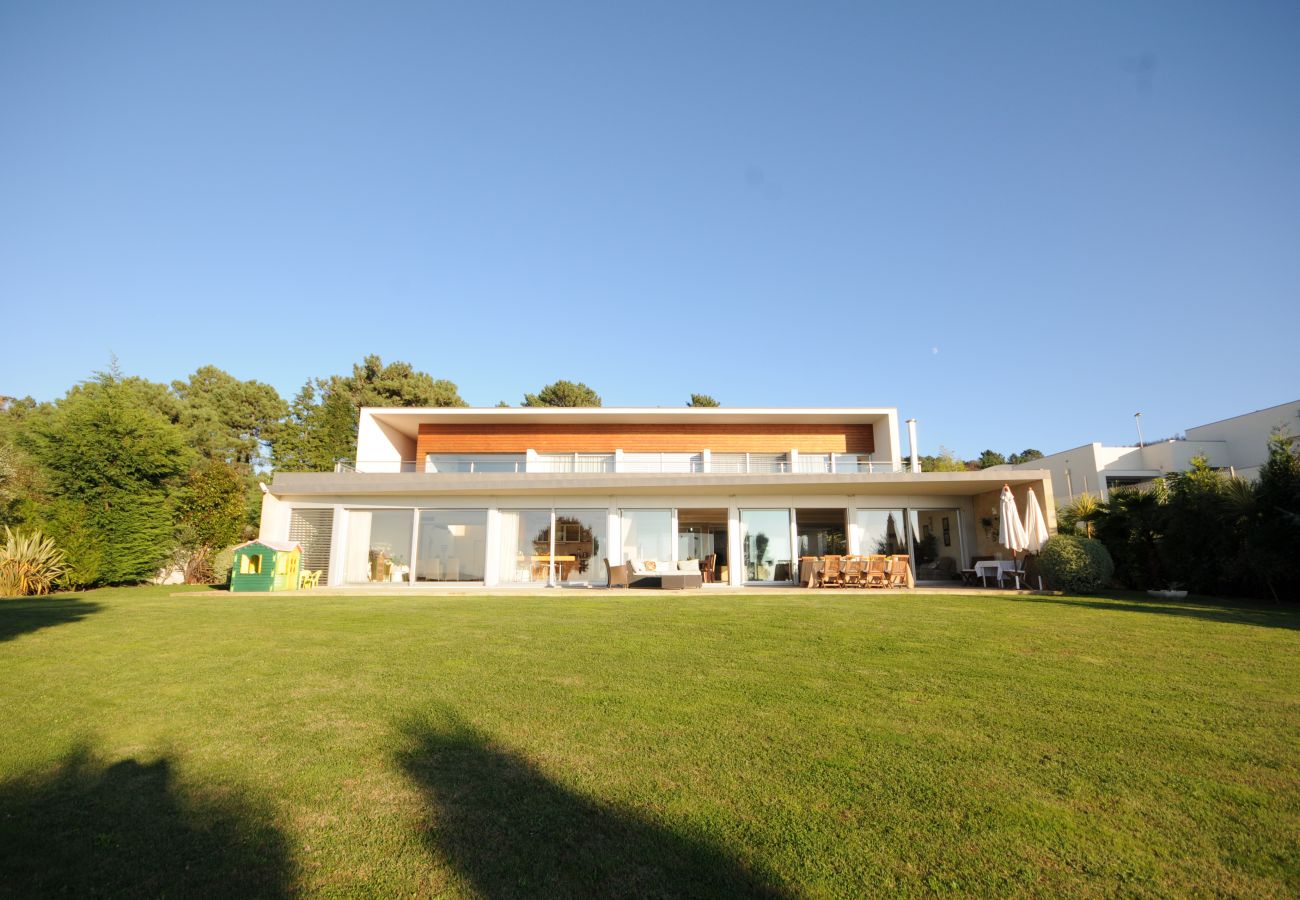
xmin=996 ymin=401 xmax=1300 ymax=503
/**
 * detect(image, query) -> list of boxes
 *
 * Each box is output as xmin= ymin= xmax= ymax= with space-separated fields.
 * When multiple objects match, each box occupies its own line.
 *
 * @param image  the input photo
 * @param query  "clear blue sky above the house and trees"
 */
xmin=0 ymin=0 xmax=1300 ymax=457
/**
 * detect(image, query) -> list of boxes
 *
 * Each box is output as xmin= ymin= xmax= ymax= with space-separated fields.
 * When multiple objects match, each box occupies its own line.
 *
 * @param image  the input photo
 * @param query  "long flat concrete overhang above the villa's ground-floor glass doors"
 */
xmin=270 ymin=470 xmax=1050 ymax=497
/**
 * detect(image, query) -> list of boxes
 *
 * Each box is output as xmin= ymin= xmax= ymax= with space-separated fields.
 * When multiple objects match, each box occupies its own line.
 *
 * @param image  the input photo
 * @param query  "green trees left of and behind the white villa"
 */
xmin=0 ymin=355 xmax=718 ymax=588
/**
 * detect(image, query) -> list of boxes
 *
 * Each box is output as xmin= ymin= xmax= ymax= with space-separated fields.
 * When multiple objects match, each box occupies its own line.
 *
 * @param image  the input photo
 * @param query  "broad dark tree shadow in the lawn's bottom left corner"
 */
xmin=0 ymin=749 xmax=295 ymax=897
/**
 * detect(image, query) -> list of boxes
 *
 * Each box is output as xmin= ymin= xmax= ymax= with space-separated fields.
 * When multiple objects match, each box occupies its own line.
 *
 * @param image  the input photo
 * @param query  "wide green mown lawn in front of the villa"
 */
xmin=0 ymin=588 xmax=1300 ymax=897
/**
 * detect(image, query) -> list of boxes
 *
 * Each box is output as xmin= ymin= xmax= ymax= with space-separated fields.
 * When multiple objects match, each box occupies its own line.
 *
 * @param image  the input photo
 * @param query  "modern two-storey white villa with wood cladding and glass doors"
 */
xmin=261 ymin=407 xmax=1056 ymax=588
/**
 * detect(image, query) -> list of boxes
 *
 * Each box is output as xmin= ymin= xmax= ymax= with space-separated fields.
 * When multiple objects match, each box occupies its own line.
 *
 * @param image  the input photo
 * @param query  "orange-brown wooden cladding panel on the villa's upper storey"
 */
xmin=416 ymin=424 xmax=876 ymax=459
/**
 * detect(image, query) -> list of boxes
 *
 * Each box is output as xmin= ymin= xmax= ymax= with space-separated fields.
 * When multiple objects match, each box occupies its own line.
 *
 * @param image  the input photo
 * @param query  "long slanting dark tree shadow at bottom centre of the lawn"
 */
xmin=398 ymin=714 xmax=787 ymax=897
